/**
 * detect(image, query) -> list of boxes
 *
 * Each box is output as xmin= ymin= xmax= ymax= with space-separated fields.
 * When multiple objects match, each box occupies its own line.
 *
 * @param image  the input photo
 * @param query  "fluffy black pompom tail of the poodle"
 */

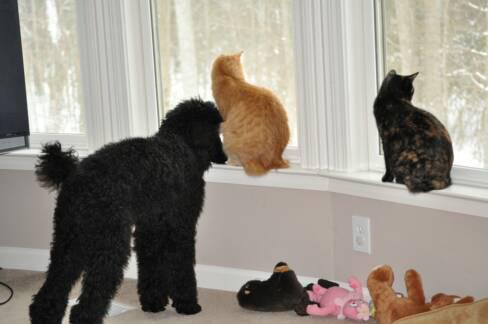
xmin=36 ymin=141 xmax=79 ymax=189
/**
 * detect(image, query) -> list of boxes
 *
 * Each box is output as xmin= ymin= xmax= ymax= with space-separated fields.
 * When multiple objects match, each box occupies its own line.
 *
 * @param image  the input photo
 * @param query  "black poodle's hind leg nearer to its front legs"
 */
xmin=70 ymin=224 xmax=131 ymax=324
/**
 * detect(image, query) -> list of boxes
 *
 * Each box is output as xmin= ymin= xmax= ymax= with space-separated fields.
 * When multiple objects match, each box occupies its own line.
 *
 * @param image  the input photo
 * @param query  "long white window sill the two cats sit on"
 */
xmin=0 ymin=150 xmax=488 ymax=217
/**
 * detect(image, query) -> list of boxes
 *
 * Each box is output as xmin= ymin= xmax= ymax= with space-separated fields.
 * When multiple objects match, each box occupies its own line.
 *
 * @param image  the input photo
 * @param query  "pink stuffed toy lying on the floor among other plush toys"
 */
xmin=307 ymin=277 xmax=369 ymax=321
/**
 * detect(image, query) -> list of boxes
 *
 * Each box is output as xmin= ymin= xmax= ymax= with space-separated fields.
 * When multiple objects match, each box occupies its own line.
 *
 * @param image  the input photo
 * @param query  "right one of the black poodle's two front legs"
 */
xmin=167 ymin=228 xmax=202 ymax=315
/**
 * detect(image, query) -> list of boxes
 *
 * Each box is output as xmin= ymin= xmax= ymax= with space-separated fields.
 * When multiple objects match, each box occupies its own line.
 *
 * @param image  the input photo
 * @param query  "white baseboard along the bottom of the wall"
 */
xmin=0 ymin=247 xmax=369 ymax=301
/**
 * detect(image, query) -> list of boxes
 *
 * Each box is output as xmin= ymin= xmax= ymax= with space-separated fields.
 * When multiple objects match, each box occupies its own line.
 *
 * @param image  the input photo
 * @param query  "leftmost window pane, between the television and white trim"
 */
xmin=19 ymin=0 xmax=86 ymax=139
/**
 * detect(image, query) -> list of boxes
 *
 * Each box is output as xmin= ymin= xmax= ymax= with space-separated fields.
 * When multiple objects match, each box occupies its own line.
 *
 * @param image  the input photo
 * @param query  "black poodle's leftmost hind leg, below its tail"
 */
xmin=29 ymin=211 xmax=83 ymax=324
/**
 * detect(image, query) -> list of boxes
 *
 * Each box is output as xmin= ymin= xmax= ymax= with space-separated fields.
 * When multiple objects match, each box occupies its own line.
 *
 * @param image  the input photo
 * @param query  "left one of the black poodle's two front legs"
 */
xmin=134 ymin=224 xmax=168 ymax=313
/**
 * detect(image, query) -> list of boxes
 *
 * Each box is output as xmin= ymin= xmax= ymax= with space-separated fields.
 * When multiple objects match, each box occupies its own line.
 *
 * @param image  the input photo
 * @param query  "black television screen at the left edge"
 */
xmin=0 ymin=0 xmax=29 ymax=151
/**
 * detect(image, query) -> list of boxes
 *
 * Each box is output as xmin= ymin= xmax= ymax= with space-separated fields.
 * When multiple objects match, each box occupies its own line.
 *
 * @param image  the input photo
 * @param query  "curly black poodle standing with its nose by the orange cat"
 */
xmin=30 ymin=99 xmax=227 ymax=324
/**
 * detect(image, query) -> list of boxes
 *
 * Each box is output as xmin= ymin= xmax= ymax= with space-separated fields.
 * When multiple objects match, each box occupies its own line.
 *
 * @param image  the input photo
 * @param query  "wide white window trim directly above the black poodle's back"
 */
xmin=77 ymin=0 xmax=159 ymax=150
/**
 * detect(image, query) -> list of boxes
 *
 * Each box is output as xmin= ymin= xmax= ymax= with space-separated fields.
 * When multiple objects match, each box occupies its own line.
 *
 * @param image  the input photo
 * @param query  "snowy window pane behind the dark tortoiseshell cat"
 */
xmin=380 ymin=0 xmax=488 ymax=169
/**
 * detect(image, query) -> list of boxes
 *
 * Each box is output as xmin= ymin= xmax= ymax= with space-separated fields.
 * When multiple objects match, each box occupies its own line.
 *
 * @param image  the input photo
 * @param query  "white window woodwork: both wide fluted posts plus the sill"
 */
xmin=0 ymin=0 xmax=488 ymax=217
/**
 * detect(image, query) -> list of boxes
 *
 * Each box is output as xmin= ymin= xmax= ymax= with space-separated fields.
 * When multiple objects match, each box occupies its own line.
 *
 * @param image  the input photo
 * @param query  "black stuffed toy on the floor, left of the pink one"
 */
xmin=237 ymin=262 xmax=337 ymax=315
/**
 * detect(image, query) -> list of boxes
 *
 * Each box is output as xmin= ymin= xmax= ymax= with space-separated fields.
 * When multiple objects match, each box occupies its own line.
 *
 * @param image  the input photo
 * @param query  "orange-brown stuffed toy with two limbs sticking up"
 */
xmin=368 ymin=265 xmax=473 ymax=324
